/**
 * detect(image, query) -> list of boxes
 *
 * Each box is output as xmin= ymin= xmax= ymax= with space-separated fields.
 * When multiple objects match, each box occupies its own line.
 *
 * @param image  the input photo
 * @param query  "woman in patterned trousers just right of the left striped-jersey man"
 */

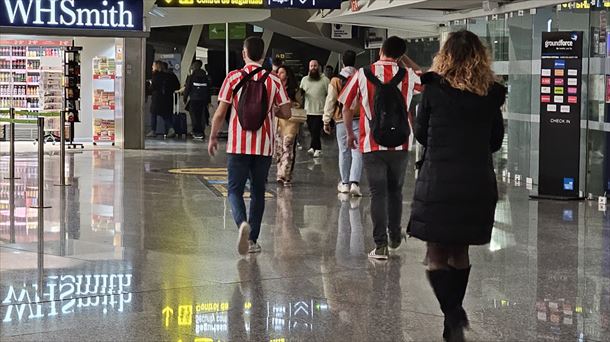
xmin=275 ymin=66 xmax=307 ymax=186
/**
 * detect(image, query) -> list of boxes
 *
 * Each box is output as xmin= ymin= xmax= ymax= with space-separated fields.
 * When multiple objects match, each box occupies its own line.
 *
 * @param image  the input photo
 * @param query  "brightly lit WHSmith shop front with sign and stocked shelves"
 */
xmin=0 ymin=0 xmax=147 ymax=148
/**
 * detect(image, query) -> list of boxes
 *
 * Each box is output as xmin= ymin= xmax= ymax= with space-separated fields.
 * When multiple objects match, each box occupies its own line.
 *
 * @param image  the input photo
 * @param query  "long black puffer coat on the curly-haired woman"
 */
xmin=408 ymin=73 xmax=506 ymax=245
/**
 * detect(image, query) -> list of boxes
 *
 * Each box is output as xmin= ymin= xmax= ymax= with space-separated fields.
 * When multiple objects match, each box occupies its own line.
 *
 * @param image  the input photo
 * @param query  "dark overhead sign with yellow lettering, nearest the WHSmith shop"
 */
xmin=157 ymin=0 xmax=341 ymax=9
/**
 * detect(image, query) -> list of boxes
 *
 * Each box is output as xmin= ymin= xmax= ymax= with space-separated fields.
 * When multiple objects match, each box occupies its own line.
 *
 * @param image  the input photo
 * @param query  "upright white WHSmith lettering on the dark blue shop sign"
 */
xmin=2 ymin=0 xmax=134 ymax=28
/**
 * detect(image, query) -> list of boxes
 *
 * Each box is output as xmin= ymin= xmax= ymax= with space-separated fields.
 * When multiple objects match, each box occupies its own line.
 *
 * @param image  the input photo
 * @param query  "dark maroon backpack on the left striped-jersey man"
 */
xmin=233 ymin=67 xmax=269 ymax=131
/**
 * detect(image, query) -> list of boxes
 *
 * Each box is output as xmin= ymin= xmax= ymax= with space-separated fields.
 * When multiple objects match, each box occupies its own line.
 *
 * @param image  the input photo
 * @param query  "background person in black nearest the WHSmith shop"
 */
xmin=146 ymin=61 xmax=180 ymax=138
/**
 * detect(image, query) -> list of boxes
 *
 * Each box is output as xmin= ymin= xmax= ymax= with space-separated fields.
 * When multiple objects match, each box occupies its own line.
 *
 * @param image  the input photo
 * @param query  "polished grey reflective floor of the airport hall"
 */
xmin=0 ymin=139 xmax=610 ymax=342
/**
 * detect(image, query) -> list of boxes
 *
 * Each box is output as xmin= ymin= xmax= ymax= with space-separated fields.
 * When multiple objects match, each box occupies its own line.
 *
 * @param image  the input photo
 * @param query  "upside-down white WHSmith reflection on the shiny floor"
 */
xmin=0 ymin=273 xmax=132 ymax=323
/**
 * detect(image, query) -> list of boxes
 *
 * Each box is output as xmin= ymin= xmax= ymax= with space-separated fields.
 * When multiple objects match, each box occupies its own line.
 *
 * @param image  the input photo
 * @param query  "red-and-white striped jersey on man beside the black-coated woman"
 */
xmin=339 ymin=61 xmax=422 ymax=153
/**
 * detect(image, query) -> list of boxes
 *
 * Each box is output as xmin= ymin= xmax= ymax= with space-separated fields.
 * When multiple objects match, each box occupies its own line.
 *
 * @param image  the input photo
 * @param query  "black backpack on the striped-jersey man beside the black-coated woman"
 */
xmin=364 ymin=68 xmax=411 ymax=147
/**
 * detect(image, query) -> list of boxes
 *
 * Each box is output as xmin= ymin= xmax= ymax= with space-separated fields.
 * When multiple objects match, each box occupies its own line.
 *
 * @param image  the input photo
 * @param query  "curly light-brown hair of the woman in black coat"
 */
xmin=431 ymin=30 xmax=496 ymax=96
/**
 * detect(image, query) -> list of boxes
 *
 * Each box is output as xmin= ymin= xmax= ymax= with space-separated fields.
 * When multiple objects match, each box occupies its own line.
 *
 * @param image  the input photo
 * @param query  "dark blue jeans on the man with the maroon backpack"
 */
xmin=227 ymin=154 xmax=271 ymax=242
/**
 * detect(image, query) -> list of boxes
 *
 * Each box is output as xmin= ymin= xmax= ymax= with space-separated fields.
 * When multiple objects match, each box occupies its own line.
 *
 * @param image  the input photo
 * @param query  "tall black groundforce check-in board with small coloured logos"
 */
xmin=538 ymin=32 xmax=583 ymax=199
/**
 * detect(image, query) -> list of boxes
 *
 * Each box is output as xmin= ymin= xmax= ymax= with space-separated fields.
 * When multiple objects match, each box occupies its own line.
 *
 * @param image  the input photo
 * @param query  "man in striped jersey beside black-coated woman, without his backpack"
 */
xmin=339 ymin=37 xmax=421 ymax=260
